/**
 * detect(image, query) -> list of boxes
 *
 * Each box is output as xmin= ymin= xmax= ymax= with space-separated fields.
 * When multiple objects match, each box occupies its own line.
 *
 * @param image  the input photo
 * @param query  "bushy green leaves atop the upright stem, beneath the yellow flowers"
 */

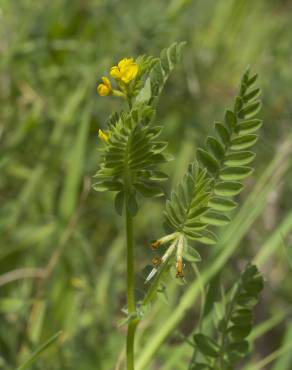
xmin=94 ymin=43 xmax=183 ymax=216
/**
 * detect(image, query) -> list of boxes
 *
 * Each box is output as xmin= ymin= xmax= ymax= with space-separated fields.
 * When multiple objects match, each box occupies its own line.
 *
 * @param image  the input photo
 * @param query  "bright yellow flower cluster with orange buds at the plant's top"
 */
xmin=97 ymin=58 xmax=139 ymax=98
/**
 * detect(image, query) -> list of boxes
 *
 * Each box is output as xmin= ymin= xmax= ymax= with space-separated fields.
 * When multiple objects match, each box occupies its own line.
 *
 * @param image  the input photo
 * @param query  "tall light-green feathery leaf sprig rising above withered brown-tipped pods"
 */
xmin=147 ymin=70 xmax=262 ymax=280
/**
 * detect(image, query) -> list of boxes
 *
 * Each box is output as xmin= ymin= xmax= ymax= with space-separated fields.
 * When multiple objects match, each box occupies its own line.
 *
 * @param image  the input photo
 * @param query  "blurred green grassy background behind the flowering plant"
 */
xmin=0 ymin=0 xmax=292 ymax=370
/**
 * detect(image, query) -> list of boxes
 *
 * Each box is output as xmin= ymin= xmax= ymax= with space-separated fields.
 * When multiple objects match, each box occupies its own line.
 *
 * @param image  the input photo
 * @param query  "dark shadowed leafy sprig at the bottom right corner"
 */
xmin=189 ymin=264 xmax=264 ymax=370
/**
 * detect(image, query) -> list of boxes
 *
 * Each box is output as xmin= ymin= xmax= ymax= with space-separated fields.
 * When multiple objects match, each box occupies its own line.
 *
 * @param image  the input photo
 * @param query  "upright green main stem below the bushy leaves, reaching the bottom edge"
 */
xmin=125 ymin=204 xmax=138 ymax=370
